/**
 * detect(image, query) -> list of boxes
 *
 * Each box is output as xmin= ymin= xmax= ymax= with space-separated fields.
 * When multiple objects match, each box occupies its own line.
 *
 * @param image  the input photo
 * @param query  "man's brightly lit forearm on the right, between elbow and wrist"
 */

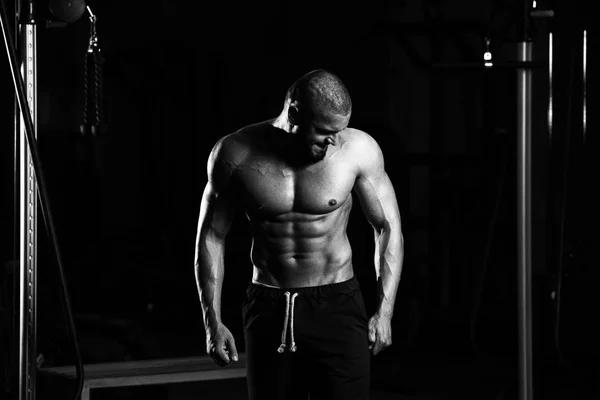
xmin=375 ymin=225 xmax=404 ymax=318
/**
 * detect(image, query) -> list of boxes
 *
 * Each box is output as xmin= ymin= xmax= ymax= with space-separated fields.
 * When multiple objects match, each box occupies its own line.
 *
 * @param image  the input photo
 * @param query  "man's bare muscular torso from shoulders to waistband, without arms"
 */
xmin=224 ymin=123 xmax=357 ymax=288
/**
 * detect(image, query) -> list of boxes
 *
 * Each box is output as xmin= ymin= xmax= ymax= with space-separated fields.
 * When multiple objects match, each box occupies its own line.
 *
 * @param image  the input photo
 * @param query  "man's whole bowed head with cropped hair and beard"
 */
xmin=286 ymin=69 xmax=352 ymax=162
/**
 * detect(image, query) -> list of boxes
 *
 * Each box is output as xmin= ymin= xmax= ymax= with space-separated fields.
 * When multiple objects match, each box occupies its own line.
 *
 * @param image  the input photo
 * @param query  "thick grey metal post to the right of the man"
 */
xmin=517 ymin=40 xmax=533 ymax=400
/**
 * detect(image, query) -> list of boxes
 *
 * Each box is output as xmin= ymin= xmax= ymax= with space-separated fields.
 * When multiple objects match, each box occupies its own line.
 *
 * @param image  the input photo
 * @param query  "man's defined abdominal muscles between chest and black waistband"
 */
xmin=251 ymin=209 xmax=353 ymax=288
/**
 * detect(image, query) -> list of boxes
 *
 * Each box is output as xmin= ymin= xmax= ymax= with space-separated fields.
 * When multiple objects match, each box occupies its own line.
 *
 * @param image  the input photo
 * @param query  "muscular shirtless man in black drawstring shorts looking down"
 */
xmin=195 ymin=70 xmax=403 ymax=400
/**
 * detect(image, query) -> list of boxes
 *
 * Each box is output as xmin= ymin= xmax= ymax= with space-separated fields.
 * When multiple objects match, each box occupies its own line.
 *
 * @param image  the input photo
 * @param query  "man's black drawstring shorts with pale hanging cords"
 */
xmin=243 ymin=278 xmax=370 ymax=400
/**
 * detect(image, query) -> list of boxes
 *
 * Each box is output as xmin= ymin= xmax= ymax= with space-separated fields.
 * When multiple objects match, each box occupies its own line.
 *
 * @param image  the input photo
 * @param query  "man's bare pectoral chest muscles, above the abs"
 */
xmin=236 ymin=161 xmax=356 ymax=214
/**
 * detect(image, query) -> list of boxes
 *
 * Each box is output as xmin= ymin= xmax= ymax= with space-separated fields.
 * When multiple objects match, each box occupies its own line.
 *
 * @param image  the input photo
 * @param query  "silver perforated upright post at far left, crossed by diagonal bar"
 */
xmin=19 ymin=20 xmax=37 ymax=400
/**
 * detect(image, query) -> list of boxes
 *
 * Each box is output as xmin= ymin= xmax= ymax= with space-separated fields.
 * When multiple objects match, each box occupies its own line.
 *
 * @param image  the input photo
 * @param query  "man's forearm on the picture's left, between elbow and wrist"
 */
xmin=194 ymin=231 xmax=225 ymax=330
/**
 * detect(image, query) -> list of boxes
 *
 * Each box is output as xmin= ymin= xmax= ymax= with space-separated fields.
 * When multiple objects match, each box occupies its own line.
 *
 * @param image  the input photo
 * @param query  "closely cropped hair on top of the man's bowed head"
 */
xmin=286 ymin=69 xmax=352 ymax=115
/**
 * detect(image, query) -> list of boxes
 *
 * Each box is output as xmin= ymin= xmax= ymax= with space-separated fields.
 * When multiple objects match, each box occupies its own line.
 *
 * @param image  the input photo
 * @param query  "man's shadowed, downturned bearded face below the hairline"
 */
xmin=298 ymin=110 xmax=350 ymax=162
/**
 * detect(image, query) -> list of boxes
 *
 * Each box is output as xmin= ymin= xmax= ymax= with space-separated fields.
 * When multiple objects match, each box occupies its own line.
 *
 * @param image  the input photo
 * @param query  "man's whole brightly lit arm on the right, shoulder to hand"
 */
xmin=355 ymin=135 xmax=404 ymax=354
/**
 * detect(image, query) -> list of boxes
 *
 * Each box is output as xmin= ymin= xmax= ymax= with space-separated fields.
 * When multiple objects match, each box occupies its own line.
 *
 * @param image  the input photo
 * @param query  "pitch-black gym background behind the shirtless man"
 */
xmin=0 ymin=0 xmax=600 ymax=398
